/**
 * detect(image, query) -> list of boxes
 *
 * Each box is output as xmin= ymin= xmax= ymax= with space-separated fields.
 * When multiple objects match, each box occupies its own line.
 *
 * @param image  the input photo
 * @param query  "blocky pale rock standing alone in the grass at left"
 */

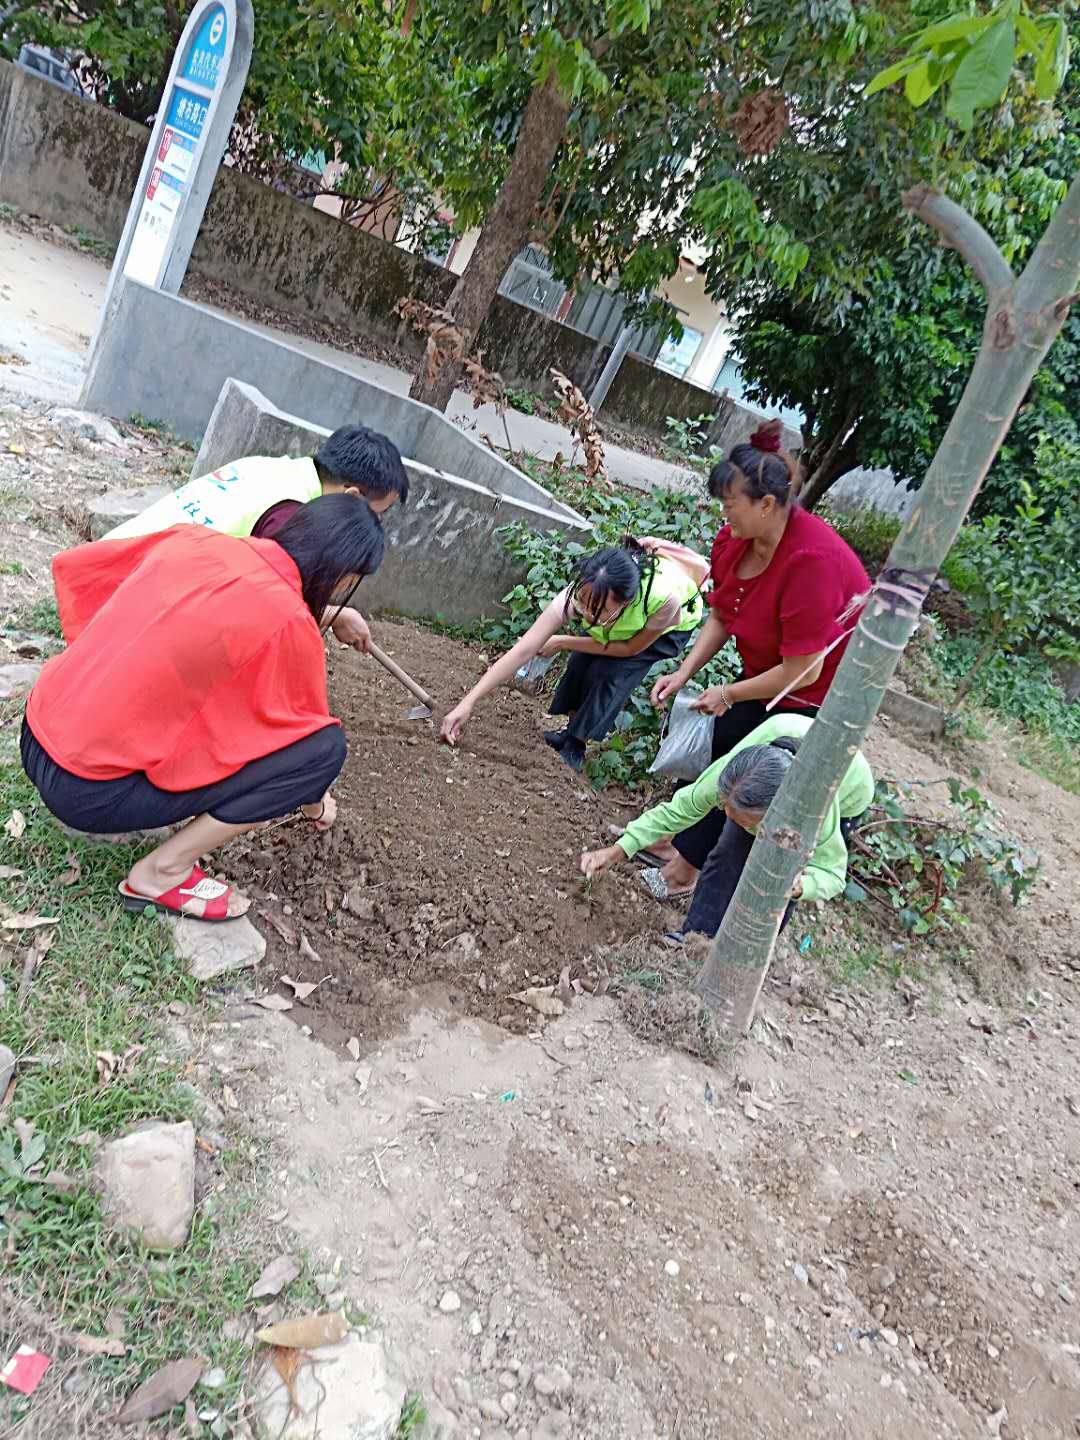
xmin=98 ymin=1120 xmax=194 ymax=1250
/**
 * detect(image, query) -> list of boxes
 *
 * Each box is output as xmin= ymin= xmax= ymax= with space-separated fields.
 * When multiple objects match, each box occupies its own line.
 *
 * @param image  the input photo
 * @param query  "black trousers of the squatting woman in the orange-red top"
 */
xmin=22 ymin=720 xmax=347 ymax=835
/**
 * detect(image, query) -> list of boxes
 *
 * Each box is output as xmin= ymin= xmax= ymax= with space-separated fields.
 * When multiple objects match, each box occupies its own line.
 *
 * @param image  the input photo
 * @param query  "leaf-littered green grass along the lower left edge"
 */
xmin=0 ymin=720 xmax=255 ymax=1436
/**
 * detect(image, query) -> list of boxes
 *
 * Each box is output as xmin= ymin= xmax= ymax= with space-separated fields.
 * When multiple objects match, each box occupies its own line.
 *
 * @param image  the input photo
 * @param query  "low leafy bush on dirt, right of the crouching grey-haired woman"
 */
xmin=845 ymin=779 xmax=1038 ymax=935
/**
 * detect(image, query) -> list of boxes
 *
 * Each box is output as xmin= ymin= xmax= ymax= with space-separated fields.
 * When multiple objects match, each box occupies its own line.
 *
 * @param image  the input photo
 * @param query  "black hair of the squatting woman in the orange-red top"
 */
xmin=274 ymin=495 xmax=383 ymax=628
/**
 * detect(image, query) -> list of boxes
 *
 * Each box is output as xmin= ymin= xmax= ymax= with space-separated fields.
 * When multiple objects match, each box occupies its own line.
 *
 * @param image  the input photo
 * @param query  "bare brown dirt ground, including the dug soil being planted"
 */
xmin=0 ymin=394 xmax=1080 ymax=1440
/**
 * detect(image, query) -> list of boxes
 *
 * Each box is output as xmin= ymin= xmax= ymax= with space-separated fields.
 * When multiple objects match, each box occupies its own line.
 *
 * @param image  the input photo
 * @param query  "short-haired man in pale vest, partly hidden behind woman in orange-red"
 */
xmin=104 ymin=425 xmax=409 ymax=654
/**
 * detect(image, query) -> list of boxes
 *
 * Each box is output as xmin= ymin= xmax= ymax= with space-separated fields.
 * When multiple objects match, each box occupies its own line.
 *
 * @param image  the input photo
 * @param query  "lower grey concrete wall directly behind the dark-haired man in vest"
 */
xmin=192 ymin=380 xmax=592 ymax=624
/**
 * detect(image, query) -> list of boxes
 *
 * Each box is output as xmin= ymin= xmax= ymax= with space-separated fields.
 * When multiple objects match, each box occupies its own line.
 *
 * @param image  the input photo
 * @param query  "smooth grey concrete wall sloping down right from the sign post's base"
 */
xmin=81 ymin=281 xmax=576 ymax=518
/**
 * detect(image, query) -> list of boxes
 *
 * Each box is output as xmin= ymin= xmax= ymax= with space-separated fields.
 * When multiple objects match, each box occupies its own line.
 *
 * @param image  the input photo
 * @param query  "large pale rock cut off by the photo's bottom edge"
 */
xmin=253 ymin=1335 xmax=405 ymax=1440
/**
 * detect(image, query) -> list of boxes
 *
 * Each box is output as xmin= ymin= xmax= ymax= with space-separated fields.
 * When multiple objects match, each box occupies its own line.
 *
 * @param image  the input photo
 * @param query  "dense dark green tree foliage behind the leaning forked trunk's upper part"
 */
xmin=734 ymin=22 xmax=1080 ymax=514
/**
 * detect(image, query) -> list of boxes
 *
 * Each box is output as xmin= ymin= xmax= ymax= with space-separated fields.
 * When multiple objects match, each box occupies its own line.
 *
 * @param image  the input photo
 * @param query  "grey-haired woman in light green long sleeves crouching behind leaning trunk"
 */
xmin=580 ymin=711 xmax=874 ymax=940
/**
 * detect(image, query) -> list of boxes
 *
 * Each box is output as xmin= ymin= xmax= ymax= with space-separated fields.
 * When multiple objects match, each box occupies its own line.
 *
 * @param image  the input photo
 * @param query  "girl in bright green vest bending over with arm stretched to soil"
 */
xmin=441 ymin=536 xmax=708 ymax=770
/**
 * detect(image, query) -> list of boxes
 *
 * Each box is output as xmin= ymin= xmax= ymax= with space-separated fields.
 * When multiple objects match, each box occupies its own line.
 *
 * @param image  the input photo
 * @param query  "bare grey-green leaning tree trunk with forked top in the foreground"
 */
xmin=697 ymin=179 xmax=1080 ymax=1038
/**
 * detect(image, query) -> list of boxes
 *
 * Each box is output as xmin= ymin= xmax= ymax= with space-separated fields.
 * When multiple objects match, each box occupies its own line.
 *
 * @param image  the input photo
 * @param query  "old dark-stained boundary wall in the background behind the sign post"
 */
xmin=0 ymin=62 xmax=757 ymax=435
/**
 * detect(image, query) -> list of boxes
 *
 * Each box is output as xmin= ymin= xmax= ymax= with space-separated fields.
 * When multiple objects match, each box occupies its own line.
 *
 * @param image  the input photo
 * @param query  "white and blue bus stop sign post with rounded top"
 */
xmin=91 ymin=0 xmax=255 ymax=357
